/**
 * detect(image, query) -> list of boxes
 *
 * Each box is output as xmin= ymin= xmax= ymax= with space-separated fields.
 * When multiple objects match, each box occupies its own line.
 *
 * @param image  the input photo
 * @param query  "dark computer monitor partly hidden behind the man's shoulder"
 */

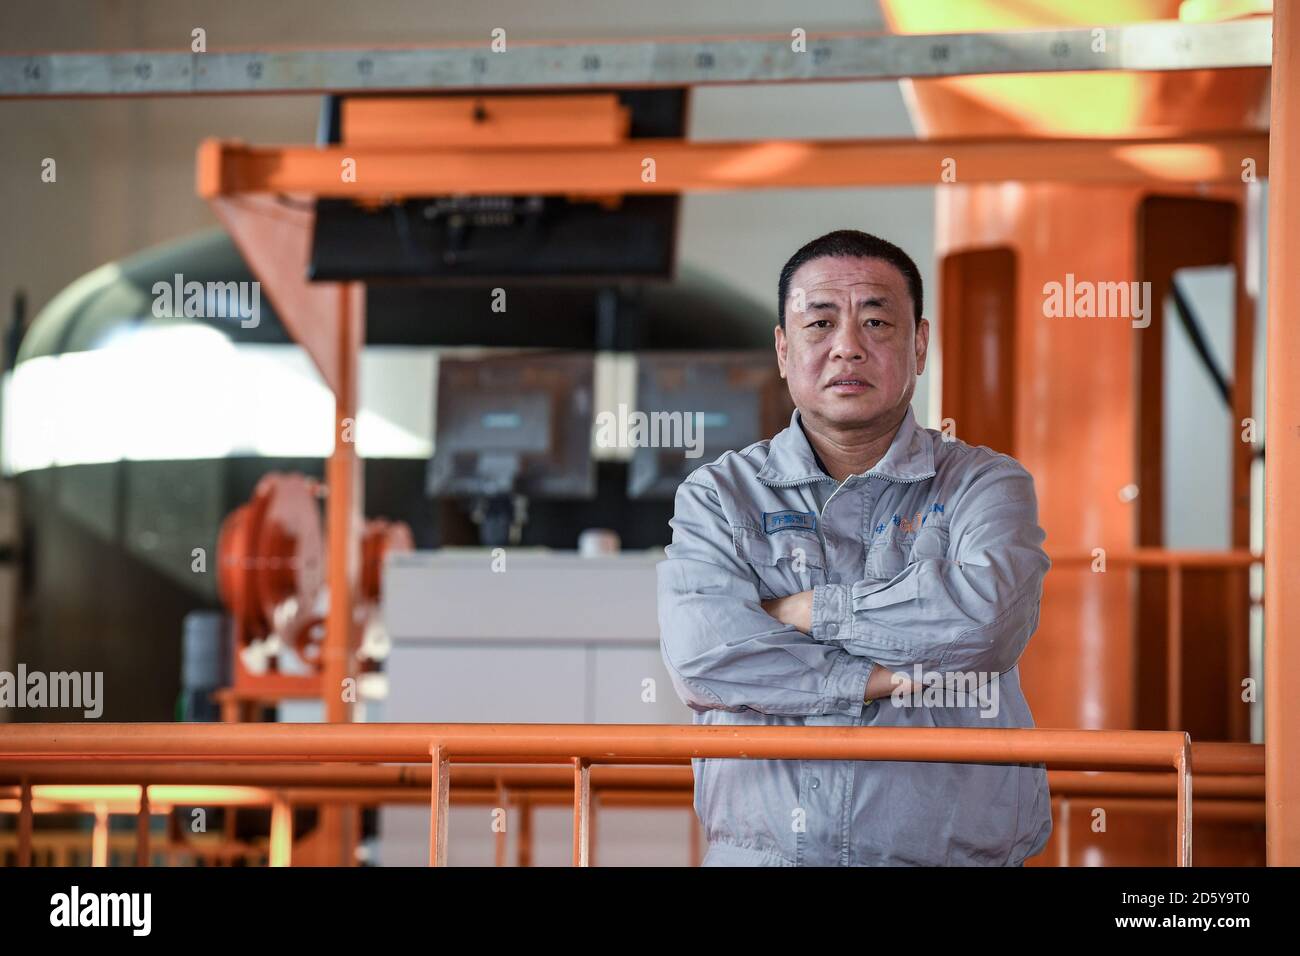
xmin=628 ymin=350 xmax=794 ymax=498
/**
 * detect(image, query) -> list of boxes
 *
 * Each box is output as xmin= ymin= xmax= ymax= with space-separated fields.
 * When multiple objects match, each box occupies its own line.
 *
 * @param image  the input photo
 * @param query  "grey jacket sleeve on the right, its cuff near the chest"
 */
xmin=813 ymin=459 xmax=1052 ymax=674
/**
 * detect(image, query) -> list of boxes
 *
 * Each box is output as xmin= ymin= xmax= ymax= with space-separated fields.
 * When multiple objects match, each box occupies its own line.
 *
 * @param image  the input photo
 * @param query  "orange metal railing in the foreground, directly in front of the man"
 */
xmin=0 ymin=723 xmax=1192 ymax=866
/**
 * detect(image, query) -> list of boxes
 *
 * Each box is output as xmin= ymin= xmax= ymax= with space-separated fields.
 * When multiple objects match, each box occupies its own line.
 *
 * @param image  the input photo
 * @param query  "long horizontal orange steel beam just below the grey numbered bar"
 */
xmin=199 ymin=133 xmax=1268 ymax=199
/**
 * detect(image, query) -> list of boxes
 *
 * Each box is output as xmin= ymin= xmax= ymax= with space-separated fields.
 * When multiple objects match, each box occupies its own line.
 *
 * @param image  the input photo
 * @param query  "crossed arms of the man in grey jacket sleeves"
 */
xmin=659 ymin=459 xmax=1050 ymax=714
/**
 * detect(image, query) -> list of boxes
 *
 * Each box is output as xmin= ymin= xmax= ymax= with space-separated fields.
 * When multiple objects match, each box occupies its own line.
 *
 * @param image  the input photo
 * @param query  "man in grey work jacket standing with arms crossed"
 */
xmin=658 ymin=230 xmax=1052 ymax=866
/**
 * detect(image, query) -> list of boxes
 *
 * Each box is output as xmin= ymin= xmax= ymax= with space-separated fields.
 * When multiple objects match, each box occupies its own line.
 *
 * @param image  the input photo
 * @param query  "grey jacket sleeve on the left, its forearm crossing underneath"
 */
xmin=658 ymin=475 xmax=874 ymax=717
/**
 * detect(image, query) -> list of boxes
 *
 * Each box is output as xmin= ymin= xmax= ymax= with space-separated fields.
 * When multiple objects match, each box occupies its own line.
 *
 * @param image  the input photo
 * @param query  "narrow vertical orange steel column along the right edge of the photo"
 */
xmin=1264 ymin=3 xmax=1300 ymax=866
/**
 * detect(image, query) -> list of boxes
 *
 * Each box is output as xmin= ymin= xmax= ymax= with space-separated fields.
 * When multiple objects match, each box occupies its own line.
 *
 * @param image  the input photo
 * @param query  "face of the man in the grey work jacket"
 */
xmin=776 ymin=256 xmax=930 ymax=429
